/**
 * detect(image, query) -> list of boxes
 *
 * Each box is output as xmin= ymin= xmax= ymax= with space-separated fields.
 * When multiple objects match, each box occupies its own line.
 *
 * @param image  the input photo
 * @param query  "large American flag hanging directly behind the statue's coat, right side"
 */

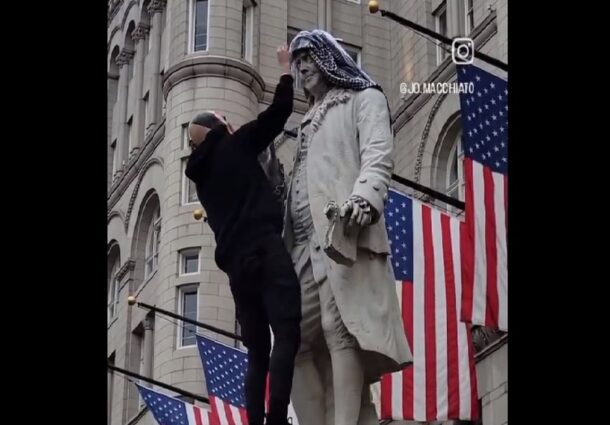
xmin=380 ymin=189 xmax=479 ymax=421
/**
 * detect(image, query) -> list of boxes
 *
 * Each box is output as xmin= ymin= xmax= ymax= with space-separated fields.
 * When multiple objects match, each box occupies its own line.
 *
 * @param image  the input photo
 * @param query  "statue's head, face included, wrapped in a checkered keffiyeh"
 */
xmin=290 ymin=30 xmax=379 ymax=102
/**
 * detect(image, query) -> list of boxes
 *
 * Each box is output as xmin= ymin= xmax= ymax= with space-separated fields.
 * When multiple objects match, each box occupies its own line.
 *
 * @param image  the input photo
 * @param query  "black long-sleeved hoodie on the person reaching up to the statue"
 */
xmin=185 ymin=74 xmax=294 ymax=271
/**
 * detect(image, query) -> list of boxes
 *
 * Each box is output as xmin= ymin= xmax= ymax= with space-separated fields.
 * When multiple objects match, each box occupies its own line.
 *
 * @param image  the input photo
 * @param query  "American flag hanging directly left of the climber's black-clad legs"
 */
xmin=197 ymin=335 xmax=248 ymax=425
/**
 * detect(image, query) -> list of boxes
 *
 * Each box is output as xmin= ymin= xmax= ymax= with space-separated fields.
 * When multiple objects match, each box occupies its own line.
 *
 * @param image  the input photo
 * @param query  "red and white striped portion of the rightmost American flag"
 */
xmin=462 ymin=158 xmax=508 ymax=331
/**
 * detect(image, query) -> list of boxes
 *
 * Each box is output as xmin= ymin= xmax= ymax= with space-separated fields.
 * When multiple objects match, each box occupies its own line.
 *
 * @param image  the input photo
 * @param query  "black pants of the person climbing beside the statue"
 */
xmin=228 ymin=235 xmax=301 ymax=425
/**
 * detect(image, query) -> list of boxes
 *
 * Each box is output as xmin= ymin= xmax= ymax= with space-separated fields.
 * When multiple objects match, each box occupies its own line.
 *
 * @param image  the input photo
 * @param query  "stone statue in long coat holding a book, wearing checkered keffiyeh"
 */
xmin=284 ymin=30 xmax=412 ymax=425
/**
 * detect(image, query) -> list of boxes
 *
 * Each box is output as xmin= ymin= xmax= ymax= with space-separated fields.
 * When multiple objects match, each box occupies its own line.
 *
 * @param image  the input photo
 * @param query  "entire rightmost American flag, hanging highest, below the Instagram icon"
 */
xmin=458 ymin=65 xmax=508 ymax=330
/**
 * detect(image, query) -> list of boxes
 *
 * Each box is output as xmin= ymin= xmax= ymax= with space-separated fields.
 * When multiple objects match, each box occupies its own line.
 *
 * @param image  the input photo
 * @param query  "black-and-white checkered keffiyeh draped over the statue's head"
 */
xmin=290 ymin=30 xmax=383 ymax=91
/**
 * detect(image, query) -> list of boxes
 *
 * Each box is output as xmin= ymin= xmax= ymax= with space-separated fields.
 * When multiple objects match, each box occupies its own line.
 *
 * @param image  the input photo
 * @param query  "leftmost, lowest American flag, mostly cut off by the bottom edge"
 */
xmin=136 ymin=384 xmax=215 ymax=425
